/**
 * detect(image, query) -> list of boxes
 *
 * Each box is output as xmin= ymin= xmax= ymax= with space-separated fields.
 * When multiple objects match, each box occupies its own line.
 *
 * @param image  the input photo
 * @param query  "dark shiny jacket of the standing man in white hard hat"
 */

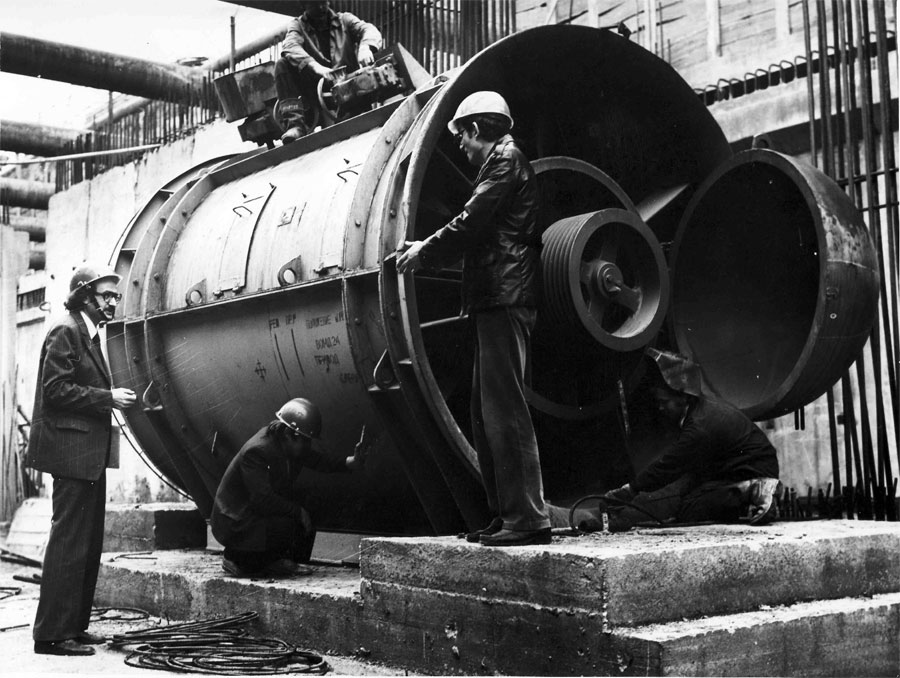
xmin=420 ymin=134 xmax=541 ymax=312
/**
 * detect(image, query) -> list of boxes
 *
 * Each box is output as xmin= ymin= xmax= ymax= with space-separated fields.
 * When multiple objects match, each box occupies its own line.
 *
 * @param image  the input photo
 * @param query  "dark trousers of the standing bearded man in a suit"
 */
xmin=32 ymin=471 xmax=106 ymax=641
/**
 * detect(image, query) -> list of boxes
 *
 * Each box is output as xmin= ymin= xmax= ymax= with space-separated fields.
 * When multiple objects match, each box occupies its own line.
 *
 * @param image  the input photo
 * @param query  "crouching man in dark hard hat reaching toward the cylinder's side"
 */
xmin=210 ymin=398 xmax=372 ymax=577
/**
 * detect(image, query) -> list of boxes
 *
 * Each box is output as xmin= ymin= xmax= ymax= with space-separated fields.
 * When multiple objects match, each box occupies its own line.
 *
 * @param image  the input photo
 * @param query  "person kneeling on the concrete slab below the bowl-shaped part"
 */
xmin=583 ymin=348 xmax=780 ymax=532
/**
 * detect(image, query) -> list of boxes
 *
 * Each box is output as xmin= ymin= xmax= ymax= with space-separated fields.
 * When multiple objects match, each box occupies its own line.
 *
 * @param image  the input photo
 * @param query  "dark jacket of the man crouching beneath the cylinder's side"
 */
xmin=210 ymin=426 xmax=347 ymax=551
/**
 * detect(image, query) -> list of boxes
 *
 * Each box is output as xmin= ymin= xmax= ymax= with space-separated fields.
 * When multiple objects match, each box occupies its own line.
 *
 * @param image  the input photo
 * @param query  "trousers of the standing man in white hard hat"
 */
xmin=471 ymin=307 xmax=550 ymax=530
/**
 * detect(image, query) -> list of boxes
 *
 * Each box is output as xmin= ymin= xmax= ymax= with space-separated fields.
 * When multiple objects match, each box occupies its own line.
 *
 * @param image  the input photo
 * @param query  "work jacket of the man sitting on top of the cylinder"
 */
xmin=281 ymin=10 xmax=381 ymax=73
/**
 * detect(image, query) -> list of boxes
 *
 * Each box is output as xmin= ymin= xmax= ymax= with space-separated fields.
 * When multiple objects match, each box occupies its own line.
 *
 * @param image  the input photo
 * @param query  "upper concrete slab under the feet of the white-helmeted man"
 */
xmin=360 ymin=521 xmax=900 ymax=626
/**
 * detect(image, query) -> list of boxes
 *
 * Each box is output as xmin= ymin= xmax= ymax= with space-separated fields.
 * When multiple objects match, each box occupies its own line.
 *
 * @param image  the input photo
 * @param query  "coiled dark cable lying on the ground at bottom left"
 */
xmin=110 ymin=612 xmax=331 ymax=676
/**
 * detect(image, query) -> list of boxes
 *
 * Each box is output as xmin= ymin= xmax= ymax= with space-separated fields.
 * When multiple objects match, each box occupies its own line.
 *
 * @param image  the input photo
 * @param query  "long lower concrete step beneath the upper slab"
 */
xmin=95 ymin=551 xmax=900 ymax=676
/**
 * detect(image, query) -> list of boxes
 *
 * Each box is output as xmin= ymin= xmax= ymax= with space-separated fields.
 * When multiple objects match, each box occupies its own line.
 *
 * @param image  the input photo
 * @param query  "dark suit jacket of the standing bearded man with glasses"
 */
xmin=25 ymin=311 xmax=119 ymax=480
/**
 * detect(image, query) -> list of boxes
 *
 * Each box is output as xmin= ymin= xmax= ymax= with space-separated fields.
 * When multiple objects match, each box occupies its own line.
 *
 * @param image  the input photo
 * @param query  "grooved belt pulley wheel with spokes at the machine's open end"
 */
xmin=541 ymin=208 xmax=669 ymax=352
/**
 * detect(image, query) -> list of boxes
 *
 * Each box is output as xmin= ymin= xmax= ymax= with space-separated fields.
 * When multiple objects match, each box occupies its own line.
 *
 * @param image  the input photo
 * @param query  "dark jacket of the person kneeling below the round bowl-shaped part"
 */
xmin=632 ymin=396 xmax=778 ymax=492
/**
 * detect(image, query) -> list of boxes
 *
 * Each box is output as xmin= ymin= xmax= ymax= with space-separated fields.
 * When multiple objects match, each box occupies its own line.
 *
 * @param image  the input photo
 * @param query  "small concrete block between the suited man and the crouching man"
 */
xmin=103 ymin=503 xmax=206 ymax=553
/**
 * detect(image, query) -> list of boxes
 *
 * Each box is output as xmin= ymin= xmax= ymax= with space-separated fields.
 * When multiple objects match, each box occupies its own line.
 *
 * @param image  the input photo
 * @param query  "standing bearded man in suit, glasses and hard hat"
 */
xmin=25 ymin=264 xmax=135 ymax=656
